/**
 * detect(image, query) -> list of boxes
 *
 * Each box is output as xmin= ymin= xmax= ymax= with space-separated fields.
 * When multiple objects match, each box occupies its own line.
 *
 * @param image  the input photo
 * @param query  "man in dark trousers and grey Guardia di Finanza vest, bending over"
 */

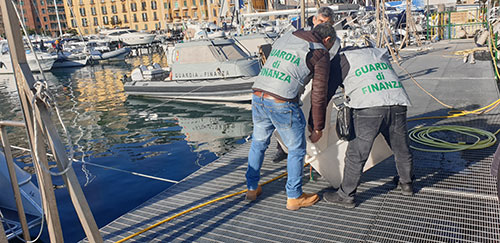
xmin=323 ymin=48 xmax=413 ymax=208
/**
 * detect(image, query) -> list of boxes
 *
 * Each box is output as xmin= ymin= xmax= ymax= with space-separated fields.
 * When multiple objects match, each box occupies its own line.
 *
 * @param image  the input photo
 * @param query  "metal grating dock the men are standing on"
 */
xmin=83 ymin=40 xmax=500 ymax=242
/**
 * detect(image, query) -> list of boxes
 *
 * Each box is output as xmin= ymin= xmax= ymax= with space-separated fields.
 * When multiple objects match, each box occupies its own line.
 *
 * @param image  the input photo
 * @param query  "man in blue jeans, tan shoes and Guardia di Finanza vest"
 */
xmin=246 ymin=24 xmax=336 ymax=210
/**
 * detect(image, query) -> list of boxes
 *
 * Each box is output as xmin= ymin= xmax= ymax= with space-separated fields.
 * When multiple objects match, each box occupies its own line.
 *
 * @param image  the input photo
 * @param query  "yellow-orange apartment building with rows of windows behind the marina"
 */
xmin=64 ymin=0 xmax=234 ymax=35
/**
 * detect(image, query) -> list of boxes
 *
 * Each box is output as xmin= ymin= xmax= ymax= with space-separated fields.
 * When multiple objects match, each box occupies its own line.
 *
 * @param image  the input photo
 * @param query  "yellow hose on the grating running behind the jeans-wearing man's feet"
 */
xmin=115 ymin=157 xmax=316 ymax=243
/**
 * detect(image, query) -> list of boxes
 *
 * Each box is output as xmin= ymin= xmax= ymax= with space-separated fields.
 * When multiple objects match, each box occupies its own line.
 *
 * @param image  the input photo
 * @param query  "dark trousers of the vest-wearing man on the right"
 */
xmin=338 ymin=106 xmax=413 ymax=199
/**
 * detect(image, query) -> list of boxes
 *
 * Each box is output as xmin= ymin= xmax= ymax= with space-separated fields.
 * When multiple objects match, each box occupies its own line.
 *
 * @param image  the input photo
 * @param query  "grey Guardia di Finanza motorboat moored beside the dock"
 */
xmin=124 ymin=39 xmax=260 ymax=101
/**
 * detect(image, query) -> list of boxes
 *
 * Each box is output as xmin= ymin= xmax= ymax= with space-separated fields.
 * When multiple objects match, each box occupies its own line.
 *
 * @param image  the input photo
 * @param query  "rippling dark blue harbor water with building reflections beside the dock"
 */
xmin=0 ymin=54 xmax=252 ymax=242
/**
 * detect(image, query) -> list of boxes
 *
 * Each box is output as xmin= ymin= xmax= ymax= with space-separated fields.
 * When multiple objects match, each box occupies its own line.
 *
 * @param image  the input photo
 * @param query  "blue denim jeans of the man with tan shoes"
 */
xmin=246 ymin=95 xmax=306 ymax=198
